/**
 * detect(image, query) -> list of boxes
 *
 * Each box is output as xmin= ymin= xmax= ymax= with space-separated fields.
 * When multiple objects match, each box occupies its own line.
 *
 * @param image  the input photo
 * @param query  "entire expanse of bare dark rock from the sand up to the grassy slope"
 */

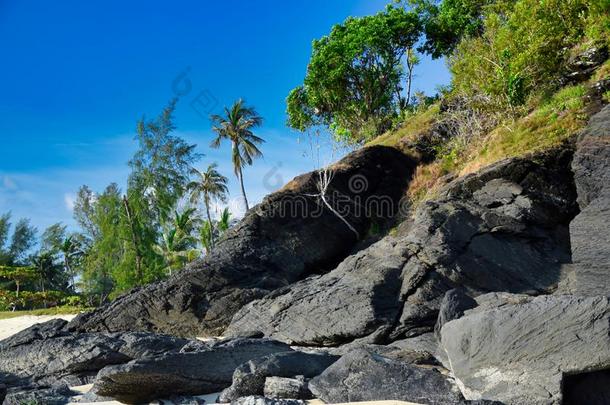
xmin=0 ymin=106 xmax=610 ymax=404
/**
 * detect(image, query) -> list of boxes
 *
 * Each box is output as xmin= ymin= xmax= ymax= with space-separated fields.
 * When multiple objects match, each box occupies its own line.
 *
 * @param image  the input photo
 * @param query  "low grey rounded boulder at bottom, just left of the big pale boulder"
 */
xmin=309 ymin=350 xmax=463 ymax=404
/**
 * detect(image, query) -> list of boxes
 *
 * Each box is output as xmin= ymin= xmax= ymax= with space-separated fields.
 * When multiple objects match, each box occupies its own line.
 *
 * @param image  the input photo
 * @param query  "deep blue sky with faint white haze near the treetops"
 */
xmin=0 ymin=0 xmax=449 ymax=230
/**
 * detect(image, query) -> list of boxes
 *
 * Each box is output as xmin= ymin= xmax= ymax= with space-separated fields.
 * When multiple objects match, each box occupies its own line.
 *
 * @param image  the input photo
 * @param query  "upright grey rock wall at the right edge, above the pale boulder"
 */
xmin=565 ymin=102 xmax=610 ymax=296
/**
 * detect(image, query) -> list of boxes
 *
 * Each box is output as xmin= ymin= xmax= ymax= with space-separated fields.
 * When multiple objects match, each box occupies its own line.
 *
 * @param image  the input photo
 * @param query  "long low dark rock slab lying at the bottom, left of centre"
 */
xmin=92 ymin=339 xmax=291 ymax=403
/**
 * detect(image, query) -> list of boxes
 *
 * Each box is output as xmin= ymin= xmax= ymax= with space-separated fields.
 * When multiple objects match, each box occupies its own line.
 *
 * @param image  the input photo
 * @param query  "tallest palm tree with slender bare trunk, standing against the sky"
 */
xmin=210 ymin=99 xmax=265 ymax=211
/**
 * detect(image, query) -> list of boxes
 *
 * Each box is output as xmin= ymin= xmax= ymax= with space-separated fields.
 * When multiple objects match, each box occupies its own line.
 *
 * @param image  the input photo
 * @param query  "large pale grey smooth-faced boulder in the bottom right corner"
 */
xmin=441 ymin=295 xmax=610 ymax=405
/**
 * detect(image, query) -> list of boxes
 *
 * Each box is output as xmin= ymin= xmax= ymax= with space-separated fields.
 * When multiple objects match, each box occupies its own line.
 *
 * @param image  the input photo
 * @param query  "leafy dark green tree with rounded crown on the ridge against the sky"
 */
xmin=287 ymin=7 xmax=421 ymax=142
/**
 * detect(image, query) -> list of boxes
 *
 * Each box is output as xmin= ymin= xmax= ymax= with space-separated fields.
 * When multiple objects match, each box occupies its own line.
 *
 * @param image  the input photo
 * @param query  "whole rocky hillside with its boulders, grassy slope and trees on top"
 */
xmin=0 ymin=0 xmax=610 ymax=405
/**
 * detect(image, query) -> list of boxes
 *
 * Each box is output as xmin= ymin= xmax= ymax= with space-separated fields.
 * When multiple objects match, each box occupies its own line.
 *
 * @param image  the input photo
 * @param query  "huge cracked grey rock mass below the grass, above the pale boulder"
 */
xmin=226 ymin=145 xmax=578 ymax=346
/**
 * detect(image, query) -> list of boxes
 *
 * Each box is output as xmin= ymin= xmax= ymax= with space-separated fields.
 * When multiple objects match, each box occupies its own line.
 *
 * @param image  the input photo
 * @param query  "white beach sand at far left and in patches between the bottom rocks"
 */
xmin=0 ymin=315 xmax=417 ymax=405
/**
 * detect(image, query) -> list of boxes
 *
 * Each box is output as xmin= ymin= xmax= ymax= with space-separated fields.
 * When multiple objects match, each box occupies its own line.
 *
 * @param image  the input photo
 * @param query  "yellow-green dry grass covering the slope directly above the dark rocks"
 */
xmin=369 ymin=83 xmax=592 ymax=206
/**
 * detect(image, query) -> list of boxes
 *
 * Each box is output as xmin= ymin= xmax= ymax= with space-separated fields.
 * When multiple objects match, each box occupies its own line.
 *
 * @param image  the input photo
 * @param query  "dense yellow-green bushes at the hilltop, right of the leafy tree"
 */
xmin=450 ymin=0 xmax=607 ymax=110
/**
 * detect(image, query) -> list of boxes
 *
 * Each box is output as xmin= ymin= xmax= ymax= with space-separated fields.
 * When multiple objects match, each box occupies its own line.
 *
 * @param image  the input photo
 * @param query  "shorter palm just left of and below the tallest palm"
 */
xmin=187 ymin=163 xmax=229 ymax=247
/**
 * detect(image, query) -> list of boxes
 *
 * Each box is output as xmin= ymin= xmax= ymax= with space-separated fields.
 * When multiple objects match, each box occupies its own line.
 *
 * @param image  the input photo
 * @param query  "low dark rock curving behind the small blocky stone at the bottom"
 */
xmin=219 ymin=352 xmax=339 ymax=403
